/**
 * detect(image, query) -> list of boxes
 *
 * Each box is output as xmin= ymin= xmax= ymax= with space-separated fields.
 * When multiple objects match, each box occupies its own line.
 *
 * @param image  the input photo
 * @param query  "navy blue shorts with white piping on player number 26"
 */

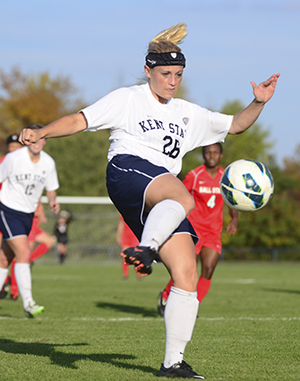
xmin=106 ymin=155 xmax=198 ymax=244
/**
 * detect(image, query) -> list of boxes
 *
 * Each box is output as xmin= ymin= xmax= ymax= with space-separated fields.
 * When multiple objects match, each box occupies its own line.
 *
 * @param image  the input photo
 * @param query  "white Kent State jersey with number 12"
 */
xmin=0 ymin=147 xmax=59 ymax=213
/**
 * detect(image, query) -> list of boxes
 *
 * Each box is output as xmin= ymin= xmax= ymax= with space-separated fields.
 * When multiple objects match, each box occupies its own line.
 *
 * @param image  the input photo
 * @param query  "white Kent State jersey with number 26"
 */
xmin=81 ymin=84 xmax=232 ymax=175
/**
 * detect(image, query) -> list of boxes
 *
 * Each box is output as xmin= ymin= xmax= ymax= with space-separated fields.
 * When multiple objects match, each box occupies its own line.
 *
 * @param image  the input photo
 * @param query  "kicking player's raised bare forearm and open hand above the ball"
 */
xmin=229 ymin=74 xmax=280 ymax=135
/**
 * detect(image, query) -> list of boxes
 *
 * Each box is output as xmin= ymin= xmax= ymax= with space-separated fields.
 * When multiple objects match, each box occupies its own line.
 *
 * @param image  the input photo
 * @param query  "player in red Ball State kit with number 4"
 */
xmin=158 ymin=143 xmax=238 ymax=316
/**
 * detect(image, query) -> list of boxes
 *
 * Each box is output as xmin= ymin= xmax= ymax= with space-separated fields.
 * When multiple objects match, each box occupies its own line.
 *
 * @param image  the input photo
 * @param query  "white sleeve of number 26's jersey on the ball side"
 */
xmin=187 ymin=105 xmax=233 ymax=150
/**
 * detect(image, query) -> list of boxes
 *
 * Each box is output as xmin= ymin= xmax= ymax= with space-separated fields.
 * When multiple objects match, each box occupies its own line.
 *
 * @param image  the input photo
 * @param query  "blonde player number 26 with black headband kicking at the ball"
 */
xmin=20 ymin=24 xmax=279 ymax=379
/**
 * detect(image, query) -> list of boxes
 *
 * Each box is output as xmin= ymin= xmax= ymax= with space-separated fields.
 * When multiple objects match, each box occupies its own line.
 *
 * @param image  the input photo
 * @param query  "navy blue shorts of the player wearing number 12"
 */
xmin=0 ymin=203 xmax=34 ymax=241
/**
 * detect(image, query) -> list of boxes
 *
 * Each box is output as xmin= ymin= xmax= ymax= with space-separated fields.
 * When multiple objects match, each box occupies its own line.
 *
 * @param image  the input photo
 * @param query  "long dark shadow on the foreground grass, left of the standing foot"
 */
xmin=0 ymin=339 xmax=157 ymax=375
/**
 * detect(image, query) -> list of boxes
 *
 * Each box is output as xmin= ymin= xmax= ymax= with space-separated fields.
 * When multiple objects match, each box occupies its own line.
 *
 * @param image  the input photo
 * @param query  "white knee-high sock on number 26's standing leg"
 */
xmin=164 ymin=287 xmax=199 ymax=368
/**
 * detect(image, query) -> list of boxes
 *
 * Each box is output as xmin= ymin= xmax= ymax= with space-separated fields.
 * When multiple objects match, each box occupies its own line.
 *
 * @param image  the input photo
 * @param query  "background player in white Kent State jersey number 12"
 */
xmin=0 ymin=124 xmax=59 ymax=317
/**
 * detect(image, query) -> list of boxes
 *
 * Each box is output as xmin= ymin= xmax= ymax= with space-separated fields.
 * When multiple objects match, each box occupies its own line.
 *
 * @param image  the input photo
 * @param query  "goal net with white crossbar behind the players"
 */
xmin=38 ymin=196 xmax=121 ymax=263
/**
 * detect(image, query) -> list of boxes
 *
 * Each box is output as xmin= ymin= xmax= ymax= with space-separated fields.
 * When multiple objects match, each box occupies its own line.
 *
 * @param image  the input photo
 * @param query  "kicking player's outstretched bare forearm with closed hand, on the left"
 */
xmin=19 ymin=112 xmax=87 ymax=145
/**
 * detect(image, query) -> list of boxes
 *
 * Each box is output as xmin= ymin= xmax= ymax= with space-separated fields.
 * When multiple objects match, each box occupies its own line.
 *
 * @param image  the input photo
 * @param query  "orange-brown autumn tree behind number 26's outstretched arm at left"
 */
xmin=0 ymin=67 xmax=83 ymax=154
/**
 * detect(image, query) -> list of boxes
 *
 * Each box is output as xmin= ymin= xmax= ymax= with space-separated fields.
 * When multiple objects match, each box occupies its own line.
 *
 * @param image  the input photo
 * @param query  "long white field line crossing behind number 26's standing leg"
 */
xmin=0 ymin=316 xmax=300 ymax=323
